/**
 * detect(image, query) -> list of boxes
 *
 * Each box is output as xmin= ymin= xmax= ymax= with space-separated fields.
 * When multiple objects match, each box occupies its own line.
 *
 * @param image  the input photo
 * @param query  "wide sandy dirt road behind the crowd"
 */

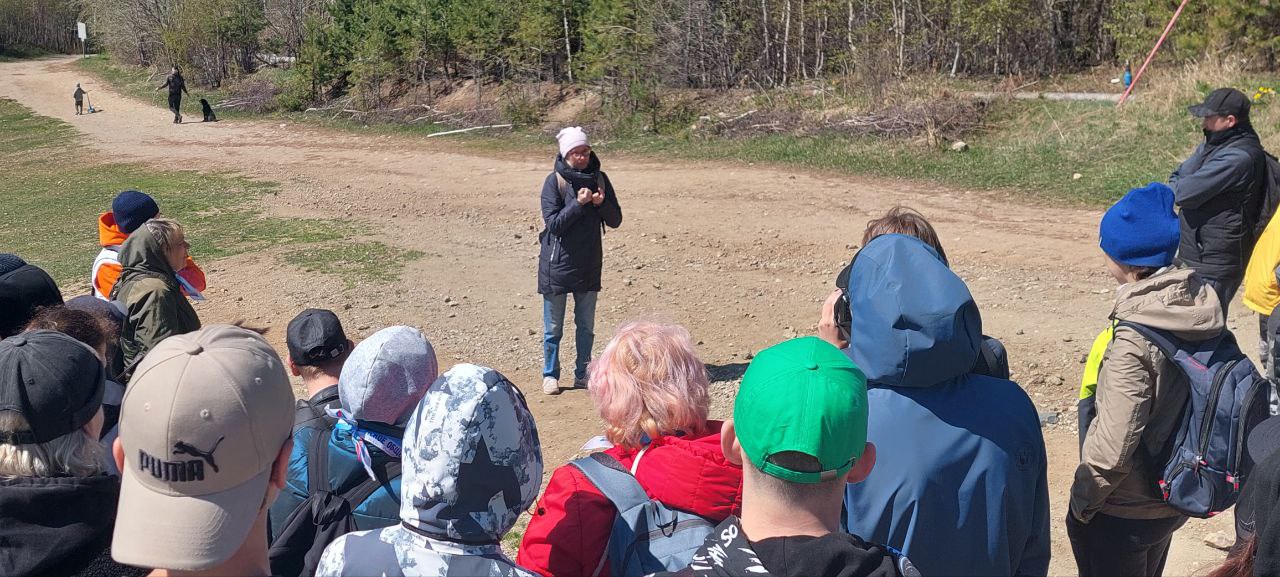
xmin=0 ymin=59 xmax=1256 ymax=576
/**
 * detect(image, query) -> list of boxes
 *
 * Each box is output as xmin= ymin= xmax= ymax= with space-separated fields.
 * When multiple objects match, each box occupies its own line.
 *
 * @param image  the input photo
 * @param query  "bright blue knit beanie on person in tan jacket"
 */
xmin=1098 ymin=183 xmax=1179 ymax=267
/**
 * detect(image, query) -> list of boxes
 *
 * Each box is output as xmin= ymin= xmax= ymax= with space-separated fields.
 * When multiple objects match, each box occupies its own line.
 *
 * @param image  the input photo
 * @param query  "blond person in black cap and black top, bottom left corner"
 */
xmin=0 ymin=330 xmax=147 ymax=577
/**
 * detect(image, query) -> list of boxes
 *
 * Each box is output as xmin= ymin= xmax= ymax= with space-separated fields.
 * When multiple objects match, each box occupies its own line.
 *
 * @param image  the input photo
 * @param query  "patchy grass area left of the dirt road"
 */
xmin=0 ymin=99 xmax=417 ymax=294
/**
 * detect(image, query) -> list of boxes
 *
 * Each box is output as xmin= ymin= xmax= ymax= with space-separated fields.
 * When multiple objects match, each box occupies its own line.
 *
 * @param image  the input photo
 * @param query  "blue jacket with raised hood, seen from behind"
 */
xmin=845 ymin=234 xmax=1050 ymax=576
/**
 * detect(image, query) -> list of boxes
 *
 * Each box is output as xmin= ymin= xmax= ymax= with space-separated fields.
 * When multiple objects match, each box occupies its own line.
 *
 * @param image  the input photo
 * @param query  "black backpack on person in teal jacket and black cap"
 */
xmin=268 ymin=429 xmax=401 ymax=577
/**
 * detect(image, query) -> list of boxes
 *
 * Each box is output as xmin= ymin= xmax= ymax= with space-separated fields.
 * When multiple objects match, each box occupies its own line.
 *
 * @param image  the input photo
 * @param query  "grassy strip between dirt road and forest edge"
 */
xmin=79 ymin=58 xmax=1280 ymax=205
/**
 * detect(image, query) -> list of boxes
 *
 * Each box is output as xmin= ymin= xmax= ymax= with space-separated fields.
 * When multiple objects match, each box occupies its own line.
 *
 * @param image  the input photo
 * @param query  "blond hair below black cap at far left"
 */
xmin=0 ymin=411 xmax=106 ymax=478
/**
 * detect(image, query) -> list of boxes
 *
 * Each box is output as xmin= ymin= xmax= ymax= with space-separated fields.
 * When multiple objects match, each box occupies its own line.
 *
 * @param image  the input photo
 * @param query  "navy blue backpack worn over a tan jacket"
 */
xmin=1117 ymin=322 xmax=1271 ymax=518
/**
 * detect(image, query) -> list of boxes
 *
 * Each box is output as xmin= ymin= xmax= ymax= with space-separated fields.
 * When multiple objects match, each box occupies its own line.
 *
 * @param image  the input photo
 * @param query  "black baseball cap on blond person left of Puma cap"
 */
xmin=0 ymin=330 xmax=106 ymax=445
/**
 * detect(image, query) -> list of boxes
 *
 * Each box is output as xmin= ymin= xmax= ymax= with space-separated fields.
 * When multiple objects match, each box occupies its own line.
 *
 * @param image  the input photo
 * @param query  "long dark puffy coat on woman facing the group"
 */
xmin=538 ymin=154 xmax=622 ymax=294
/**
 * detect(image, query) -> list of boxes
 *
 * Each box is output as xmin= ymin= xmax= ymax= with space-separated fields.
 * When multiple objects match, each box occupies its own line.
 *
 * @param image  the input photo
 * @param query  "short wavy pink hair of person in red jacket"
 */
xmin=590 ymin=321 xmax=710 ymax=448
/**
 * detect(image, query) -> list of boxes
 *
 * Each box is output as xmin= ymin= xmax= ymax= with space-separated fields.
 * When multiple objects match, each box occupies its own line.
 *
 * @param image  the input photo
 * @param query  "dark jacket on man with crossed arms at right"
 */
xmin=1169 ymin=124 xmax=1266 ymax=279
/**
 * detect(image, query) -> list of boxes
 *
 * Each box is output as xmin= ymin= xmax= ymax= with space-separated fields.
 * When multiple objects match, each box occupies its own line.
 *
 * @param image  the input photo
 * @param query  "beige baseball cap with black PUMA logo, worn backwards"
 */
xmin=111 ymin=325 xmax=293 ymax=571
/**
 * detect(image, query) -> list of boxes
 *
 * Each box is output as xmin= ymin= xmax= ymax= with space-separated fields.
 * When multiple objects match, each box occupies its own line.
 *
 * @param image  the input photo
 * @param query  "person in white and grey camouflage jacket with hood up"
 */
xmin=316 ymin=365 xmax=543 ymax=577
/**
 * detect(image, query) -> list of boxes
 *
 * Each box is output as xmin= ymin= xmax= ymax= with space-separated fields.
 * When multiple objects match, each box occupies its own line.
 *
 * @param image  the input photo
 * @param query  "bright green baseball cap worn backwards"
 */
xmin=733 ymin=336 xmax=867 ymax=484
